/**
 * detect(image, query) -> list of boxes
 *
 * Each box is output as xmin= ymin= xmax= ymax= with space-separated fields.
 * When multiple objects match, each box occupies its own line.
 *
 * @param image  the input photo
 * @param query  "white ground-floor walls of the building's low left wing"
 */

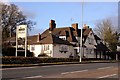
xmin=29 ymin=44 xmax=74 ymax=58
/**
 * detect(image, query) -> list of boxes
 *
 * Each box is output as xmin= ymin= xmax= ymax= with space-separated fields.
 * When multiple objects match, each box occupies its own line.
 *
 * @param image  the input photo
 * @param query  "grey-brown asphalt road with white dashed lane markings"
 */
xmin=1 ymin=63 xmax=118 ymax=80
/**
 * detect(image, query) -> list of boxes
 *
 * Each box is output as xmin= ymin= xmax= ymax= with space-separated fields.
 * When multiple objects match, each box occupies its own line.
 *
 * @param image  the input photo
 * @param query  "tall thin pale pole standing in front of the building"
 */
xmin=79 ymin=0 xmax=84 ymax=62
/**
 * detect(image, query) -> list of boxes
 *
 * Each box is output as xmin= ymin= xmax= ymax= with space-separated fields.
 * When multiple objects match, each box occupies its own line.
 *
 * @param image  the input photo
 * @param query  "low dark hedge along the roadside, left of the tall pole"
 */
xmin=1 ymin=56 xmax=79 ymax=64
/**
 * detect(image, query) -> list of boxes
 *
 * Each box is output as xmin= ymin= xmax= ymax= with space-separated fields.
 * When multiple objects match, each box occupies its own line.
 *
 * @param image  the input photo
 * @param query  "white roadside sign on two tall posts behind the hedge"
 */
xmin=16 ymin=25 xmax=27 ymax=57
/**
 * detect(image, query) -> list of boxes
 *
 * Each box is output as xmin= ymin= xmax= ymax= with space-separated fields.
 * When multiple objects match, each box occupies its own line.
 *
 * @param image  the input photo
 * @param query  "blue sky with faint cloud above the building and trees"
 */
xmin=0 ymin=2 xmax=118 ymax=35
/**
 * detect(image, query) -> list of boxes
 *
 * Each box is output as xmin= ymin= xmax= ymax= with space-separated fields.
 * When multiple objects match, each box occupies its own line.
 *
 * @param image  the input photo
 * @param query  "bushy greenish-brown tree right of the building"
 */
xmin=95 ymin=19 xmax=120 ymax=51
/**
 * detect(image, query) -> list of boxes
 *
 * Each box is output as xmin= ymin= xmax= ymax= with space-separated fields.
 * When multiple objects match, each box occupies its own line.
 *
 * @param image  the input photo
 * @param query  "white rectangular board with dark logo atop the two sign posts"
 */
xmin=17 ymin=25 xmax=27 ymax=38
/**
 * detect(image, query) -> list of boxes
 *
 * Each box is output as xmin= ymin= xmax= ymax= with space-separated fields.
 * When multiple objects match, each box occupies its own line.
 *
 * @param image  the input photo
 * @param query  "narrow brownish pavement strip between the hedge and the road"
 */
xmin=0 ymin=60 xmax=118 ymax=68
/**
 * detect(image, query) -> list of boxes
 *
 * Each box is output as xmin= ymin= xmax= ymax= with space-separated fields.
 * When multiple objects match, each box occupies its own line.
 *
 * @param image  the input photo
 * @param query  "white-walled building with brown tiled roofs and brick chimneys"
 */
xmin=3 ymin=20 xmax=108 ymax=58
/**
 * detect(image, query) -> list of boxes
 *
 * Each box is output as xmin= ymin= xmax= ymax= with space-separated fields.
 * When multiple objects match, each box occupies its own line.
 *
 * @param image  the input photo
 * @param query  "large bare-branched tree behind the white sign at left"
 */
xmin=0 ymin=3 xmax=35 ymax=40
